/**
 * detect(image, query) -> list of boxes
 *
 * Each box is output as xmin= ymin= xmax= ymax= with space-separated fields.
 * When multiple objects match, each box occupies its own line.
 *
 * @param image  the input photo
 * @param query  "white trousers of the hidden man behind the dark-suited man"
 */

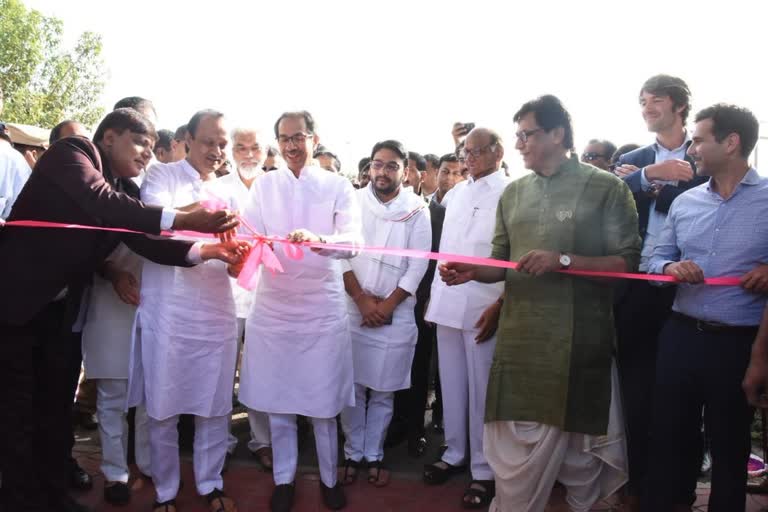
xmin=96 ymin=379 xmax=152 ymax=483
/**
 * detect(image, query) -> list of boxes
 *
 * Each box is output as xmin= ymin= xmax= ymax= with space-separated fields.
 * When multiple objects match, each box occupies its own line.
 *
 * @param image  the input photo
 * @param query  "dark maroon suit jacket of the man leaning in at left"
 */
xmin=0 ymin=137 xmax=191 ymax=325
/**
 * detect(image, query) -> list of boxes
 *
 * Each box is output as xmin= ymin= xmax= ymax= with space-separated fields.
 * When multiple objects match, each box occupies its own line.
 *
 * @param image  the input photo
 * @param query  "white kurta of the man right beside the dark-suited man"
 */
xmin=129 ymin=160 xmax=237 ymax=420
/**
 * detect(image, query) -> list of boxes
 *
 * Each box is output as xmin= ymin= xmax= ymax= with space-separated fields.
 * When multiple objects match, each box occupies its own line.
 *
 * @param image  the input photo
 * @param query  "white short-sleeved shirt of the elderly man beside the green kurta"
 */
xmin=424 ymin=171 xmax=509 ymax=329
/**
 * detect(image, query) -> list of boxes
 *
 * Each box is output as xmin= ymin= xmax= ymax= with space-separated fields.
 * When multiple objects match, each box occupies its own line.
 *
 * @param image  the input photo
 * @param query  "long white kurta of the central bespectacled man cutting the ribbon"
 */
xmin=238 ymin=167 xmax=361 ymax=418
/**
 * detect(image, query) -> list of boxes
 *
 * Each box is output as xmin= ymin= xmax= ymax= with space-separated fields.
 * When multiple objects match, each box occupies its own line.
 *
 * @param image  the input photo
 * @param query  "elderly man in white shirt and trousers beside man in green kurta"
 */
xmin=424 ymin=128 xmax=509 ymax=507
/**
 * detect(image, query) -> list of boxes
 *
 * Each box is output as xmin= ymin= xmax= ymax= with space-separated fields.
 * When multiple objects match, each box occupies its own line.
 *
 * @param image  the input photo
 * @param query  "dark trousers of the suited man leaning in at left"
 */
xmin=0 ymin=301 xmax=75 ymax=512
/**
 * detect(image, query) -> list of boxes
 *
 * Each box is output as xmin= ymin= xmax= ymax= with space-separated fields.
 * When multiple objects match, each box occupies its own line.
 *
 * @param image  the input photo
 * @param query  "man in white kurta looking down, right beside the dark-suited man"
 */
xmin=131 ymin=109 xmax=237 ymax=504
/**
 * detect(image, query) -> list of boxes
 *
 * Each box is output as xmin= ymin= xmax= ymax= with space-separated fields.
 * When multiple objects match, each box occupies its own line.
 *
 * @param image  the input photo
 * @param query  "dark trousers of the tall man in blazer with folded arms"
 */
xmin=614 ymin=281 xmax=672 ymax=496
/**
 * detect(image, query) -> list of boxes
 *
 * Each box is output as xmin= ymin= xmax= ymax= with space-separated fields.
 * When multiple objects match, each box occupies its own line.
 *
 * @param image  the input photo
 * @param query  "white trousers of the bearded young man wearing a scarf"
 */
xmin=341 ymin=384 xmax=395 ymax=462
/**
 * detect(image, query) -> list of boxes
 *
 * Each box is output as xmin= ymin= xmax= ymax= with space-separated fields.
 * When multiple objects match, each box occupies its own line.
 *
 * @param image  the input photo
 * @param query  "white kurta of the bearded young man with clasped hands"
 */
xmin=342 ymin=184 xmax=432 ymax=391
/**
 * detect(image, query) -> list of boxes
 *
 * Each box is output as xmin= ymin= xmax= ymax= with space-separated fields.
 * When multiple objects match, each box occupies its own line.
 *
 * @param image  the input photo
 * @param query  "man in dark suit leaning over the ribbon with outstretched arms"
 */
xmin=0 ymin=109 xmax=243 ymax=512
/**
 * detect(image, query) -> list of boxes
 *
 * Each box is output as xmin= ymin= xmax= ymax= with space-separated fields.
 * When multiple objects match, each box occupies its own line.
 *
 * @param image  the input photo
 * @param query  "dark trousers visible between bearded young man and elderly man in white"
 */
xmin=394 ymin=299 xmax=435 ymax=439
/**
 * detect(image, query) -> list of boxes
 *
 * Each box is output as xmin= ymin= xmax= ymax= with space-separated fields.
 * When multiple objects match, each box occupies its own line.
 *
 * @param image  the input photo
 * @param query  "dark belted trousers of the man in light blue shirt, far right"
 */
xmin=643 ymin=315 xmax=757 ymax=512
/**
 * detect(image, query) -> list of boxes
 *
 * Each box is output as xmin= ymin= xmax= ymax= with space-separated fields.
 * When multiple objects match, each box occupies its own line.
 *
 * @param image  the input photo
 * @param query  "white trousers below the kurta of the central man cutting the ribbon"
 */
xmin=269 ymin=413 xmax=339 ymax=487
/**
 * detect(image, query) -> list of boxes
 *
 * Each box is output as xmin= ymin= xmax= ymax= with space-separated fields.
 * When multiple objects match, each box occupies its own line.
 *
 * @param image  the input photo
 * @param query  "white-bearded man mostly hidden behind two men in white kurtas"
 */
xmin=219 ymin=128 xmax=272 ymax=471
